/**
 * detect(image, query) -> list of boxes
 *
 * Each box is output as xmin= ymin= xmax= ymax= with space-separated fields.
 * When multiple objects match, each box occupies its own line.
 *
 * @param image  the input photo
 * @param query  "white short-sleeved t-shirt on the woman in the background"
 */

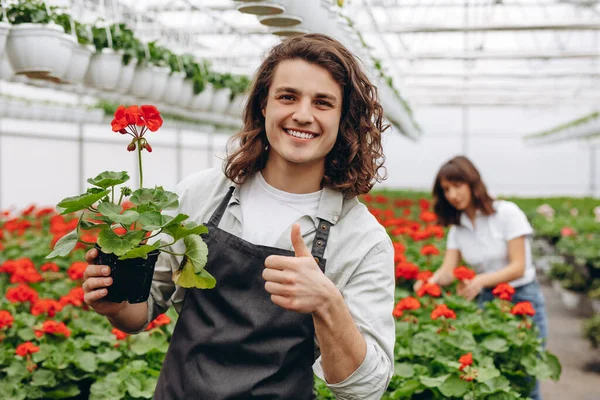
xmin=446 ymin=200 xmax=535 ymax=287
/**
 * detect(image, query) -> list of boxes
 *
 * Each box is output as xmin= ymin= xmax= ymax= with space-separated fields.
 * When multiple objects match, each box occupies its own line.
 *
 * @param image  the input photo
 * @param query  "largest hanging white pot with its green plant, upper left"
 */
xmin=6 ymin=0 xmax=73 ymax=79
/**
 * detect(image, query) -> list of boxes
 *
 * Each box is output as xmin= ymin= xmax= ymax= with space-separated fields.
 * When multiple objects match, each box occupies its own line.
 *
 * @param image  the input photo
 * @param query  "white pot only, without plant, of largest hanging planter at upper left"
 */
xmin=5 ymin=24 xmax=69 ymax=78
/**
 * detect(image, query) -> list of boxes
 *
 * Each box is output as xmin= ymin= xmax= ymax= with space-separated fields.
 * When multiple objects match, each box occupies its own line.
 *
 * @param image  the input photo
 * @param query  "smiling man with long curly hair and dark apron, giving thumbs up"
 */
xmin=84 ymin=34 xmax=395 ymax=400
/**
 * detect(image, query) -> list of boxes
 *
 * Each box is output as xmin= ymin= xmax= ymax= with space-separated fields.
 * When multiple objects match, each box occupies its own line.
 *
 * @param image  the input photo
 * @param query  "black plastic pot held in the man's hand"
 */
xmin=95 ymin=245 xmax=160 ymax=303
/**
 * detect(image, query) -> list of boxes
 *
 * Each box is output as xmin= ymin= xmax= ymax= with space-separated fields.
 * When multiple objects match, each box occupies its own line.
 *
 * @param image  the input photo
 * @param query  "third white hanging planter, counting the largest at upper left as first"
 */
xmin=84 ymin=48 xmax=123 ymax=90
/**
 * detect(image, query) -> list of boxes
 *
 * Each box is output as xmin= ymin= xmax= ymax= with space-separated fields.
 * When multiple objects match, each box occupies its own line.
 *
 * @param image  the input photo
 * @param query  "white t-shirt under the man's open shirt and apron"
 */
xmin=240 ymin=172 xmax=322 ymax=246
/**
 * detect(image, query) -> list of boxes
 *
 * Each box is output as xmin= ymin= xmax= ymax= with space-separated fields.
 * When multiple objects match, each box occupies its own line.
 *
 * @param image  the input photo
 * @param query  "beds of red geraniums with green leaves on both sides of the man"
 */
xmin=0 ymin=194 xmax=560 ymax=400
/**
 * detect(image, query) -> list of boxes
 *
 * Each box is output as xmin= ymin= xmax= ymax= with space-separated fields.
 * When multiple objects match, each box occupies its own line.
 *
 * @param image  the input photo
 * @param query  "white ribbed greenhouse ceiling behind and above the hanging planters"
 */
xmin=59 ymin=0 xmax=600 ymax=106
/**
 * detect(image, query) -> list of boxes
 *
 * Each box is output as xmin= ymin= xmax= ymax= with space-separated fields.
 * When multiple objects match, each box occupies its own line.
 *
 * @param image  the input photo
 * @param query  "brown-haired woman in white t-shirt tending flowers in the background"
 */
xmin=415 ymin=156 xmax=547 ymax=400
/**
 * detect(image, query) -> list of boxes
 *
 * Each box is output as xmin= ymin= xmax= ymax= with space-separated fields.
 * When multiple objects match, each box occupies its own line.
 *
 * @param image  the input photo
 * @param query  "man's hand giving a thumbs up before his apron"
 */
xmin=262 ymin=224 xmax=339 ymax=313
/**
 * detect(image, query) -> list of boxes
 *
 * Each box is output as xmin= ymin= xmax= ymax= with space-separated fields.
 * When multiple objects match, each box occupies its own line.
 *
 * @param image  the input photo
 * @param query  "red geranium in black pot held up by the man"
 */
xmin=47 ymin=105 xmax=216 ymax=303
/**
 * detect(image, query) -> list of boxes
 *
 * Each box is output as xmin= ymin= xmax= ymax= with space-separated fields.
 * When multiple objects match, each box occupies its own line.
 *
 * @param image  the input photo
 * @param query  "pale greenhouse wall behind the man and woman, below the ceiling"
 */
xmin=0 ymin=103 xmax=600 ymax=208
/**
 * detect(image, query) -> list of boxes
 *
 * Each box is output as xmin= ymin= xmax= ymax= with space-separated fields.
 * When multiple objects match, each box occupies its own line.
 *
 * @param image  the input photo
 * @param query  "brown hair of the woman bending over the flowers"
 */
xmin=432 ymin=156 xmax=495 ymax=226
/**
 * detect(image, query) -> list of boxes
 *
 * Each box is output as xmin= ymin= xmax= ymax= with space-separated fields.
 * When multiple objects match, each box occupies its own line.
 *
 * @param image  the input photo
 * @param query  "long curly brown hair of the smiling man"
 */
xmin=223 ymin=34 xmax=388 ymax=198
